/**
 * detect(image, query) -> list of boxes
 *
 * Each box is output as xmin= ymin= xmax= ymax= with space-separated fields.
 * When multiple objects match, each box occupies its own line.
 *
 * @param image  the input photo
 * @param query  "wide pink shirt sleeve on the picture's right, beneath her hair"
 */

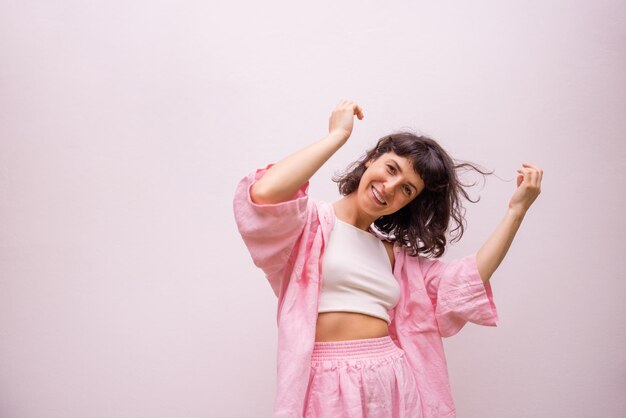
xmin=420 ymin=254 xmax=498 ymax=337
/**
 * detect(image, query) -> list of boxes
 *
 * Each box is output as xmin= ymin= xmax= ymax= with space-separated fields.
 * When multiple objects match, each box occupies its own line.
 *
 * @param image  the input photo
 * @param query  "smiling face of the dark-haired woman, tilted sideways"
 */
xmin=357 ymin=152 xmax=425 ymax=219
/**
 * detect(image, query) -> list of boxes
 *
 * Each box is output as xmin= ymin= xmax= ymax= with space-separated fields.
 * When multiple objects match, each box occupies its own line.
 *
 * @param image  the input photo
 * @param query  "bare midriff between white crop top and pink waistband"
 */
xmin=315 ymin=312 xmax=389 ymax=342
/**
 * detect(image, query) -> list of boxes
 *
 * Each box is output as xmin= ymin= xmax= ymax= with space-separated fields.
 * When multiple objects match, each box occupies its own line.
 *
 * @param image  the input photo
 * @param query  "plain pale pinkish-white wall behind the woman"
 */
xmin=0 ymin=0 xmax=626 ymax=418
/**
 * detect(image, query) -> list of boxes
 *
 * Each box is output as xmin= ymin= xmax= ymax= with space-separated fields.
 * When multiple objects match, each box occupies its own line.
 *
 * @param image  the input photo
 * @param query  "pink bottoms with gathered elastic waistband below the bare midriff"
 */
xmin=304 ymin=336 xmax=422 ymax=418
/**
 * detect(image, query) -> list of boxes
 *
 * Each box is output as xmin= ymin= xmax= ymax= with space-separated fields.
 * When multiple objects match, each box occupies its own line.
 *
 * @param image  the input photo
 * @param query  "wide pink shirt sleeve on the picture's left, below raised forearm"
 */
xmin=233 ymin=165 xmax=309 ymax=296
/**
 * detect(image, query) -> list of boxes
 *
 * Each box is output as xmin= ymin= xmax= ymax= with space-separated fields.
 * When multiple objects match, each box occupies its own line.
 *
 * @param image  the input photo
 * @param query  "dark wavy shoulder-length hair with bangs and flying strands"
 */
xmin=333 ymin=131 xmax=493 ymax=258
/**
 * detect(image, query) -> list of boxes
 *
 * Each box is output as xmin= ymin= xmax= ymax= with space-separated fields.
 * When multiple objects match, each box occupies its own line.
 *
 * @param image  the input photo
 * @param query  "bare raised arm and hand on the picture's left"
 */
xmin=251 ymin=100 xmax=363 ymax=204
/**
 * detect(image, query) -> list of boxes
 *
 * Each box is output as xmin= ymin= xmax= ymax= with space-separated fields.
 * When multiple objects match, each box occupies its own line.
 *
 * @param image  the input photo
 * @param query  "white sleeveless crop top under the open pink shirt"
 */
xmin=318 ymin=218 xmax=400 ymax=324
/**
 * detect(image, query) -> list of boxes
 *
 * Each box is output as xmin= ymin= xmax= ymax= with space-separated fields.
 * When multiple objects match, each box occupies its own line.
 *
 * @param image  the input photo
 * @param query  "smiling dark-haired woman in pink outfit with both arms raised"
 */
xmin=234 ymin=100 xmax=543 ymax=418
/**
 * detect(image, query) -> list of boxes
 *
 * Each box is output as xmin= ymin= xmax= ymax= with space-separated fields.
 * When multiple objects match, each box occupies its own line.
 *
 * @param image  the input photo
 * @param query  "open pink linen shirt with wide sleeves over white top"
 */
xmin=233 ymin=165 xmax=498 ymax=418
